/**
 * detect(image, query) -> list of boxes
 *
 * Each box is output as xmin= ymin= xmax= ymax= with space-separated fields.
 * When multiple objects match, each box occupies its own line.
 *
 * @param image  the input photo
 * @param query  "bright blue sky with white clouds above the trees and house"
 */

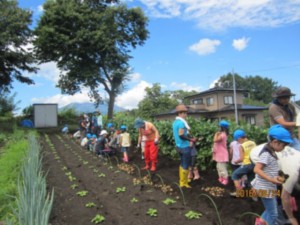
xmin=13 ymin=0 xmax=300 ymax=112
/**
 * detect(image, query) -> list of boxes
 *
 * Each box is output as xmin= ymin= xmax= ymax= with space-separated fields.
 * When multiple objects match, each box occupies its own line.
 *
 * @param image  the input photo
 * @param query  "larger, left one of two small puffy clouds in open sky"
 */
xmin=189 ymin=38 xmax=221 ymax=55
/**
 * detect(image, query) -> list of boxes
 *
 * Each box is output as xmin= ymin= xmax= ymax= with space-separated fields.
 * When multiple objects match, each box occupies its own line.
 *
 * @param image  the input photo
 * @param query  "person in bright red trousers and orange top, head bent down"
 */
xmin=134 ymin=118 xmax=159 ymax=172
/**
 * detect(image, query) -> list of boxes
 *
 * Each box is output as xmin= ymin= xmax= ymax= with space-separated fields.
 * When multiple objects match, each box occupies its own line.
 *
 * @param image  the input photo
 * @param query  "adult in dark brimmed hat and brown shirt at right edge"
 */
xmin=269 ymin=87 xmax=300 ymax=150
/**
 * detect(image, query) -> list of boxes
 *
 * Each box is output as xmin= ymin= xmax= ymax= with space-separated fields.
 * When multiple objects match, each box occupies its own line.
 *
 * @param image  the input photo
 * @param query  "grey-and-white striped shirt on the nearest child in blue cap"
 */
xmin=251 ymin=151 xmax=279 ymax=198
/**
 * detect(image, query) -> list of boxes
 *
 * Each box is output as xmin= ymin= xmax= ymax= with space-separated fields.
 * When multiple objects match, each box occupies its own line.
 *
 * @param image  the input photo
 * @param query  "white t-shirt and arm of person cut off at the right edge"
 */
xmin=276 ymin=146 xmax=300 ymax=194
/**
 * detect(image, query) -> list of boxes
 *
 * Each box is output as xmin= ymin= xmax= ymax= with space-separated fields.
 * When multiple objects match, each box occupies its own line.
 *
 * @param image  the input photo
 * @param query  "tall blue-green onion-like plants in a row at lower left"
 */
xmin=7 ymin=134 xmax=54 ymax=225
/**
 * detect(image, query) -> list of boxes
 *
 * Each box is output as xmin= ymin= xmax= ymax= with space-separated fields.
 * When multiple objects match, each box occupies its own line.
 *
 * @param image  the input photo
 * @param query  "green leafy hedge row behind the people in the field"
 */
xmin=107 ymin=115 xmax=267 ymax=170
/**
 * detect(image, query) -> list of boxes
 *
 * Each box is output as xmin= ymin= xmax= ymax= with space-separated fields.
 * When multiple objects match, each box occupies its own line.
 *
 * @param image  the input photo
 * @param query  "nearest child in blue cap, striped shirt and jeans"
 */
xmin=251 ymin=125 xmax=293 ymax=225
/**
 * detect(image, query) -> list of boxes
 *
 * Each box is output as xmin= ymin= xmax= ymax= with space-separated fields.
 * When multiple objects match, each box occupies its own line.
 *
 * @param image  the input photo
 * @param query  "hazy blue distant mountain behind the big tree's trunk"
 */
xmin=58 ymin=102 xmax=126 ymax=115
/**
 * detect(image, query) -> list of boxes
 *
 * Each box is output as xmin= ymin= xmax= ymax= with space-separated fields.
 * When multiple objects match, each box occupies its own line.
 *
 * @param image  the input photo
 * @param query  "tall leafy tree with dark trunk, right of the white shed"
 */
xmin=34 ymin=0 xmax=148 ymax=118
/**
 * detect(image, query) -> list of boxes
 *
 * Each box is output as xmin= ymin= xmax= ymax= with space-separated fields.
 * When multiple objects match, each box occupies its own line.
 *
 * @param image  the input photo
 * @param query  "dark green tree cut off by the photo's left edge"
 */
xmin=0 ymin=0 xmax=36 ymax=90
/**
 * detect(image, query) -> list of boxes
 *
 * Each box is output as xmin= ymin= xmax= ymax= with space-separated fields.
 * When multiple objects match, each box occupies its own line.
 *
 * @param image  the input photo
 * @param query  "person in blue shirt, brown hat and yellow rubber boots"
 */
xmin=173 ymin=104 xmax=196 ymax=188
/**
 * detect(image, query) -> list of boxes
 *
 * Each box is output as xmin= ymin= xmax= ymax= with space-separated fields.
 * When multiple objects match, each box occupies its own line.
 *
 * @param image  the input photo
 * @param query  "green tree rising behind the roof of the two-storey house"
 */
xmin=217 ymin=73 xmax=278 ymax=104
